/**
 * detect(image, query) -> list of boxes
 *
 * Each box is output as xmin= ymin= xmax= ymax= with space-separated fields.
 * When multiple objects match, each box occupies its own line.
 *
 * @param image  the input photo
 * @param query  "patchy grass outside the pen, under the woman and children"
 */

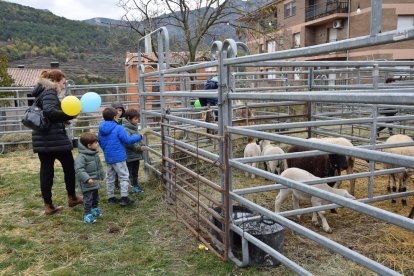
xmin=0 ymin=150 xmax=284 ymax=275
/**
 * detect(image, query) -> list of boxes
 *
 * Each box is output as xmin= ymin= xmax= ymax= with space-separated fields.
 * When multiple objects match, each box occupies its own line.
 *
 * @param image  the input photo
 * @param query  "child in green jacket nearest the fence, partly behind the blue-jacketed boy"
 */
xmin=122 ymin=108 xmax=147 ymax=193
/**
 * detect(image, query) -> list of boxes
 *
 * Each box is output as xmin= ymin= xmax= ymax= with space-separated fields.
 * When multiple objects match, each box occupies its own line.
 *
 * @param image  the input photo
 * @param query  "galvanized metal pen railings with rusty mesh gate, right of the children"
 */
xmin=138 ymin=1 xmax=414 ymax=275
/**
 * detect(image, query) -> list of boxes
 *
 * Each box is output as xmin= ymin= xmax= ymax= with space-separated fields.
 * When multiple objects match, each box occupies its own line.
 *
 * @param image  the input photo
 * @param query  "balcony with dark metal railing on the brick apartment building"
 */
xmin=305 ymin=0 xmax=348 ymax=22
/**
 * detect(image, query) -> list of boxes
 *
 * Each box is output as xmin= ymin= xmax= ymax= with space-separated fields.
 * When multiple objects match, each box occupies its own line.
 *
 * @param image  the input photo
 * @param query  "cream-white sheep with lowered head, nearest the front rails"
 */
xmin=275 ymin=168 xmax=355 ymax=233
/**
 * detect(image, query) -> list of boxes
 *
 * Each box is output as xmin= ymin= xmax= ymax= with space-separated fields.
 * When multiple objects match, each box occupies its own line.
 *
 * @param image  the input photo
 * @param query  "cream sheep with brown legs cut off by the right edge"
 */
xmin=382 ymin=134 xmax=414 ymax=205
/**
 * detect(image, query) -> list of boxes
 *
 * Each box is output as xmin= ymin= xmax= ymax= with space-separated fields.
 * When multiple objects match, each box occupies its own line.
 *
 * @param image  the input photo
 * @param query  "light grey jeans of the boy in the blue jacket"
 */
xmin=106 ymin=161 xmax=129 ymax=198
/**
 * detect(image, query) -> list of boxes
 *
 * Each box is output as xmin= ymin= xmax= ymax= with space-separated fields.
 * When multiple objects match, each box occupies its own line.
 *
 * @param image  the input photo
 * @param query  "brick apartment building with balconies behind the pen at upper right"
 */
xmin=239 ymin=0 xmax=414 ymax=61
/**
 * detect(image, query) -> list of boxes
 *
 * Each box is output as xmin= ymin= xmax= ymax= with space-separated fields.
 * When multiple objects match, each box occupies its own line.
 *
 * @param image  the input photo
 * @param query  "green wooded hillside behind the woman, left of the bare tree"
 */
xmin=0 ymin=1 xmax=133 ymax=80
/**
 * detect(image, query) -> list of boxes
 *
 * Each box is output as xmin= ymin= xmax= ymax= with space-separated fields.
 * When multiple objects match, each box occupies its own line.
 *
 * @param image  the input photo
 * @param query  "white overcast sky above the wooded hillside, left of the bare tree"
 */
xmin=6 ymin=0 xmax=123 ymax=20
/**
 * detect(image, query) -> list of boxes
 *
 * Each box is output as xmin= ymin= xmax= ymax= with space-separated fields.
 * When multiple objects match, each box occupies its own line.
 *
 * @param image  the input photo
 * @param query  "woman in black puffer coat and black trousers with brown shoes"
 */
xmin=32 ymin=70 xmax=83 ymax=215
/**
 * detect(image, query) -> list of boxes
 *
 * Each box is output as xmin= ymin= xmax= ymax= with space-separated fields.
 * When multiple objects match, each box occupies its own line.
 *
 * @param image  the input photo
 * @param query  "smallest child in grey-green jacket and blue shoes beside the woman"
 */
xmin=75 ymin=132 xmax=105 ymax=224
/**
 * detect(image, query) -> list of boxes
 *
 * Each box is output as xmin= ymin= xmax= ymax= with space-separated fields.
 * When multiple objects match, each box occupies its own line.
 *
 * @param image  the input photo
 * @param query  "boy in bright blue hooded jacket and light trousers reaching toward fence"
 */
xmin=98 ymin=107 xmax=149 ymax=206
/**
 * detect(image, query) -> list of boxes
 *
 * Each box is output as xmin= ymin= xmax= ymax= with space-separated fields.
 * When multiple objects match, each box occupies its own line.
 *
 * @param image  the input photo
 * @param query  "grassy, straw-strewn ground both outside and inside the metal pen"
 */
xmin=0 ymin=150 xmax=414 ymax=275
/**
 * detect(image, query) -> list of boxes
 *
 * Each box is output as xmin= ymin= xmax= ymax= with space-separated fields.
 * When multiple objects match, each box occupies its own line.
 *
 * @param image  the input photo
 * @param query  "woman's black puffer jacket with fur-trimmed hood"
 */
xmin=32 ymin=78 xmax=73 ymax=152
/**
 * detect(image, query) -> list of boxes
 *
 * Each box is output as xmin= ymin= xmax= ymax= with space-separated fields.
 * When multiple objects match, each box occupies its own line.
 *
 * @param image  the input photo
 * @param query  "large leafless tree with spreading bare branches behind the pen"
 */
xmin=118 ymin=0 xmax=266 ymax=61
